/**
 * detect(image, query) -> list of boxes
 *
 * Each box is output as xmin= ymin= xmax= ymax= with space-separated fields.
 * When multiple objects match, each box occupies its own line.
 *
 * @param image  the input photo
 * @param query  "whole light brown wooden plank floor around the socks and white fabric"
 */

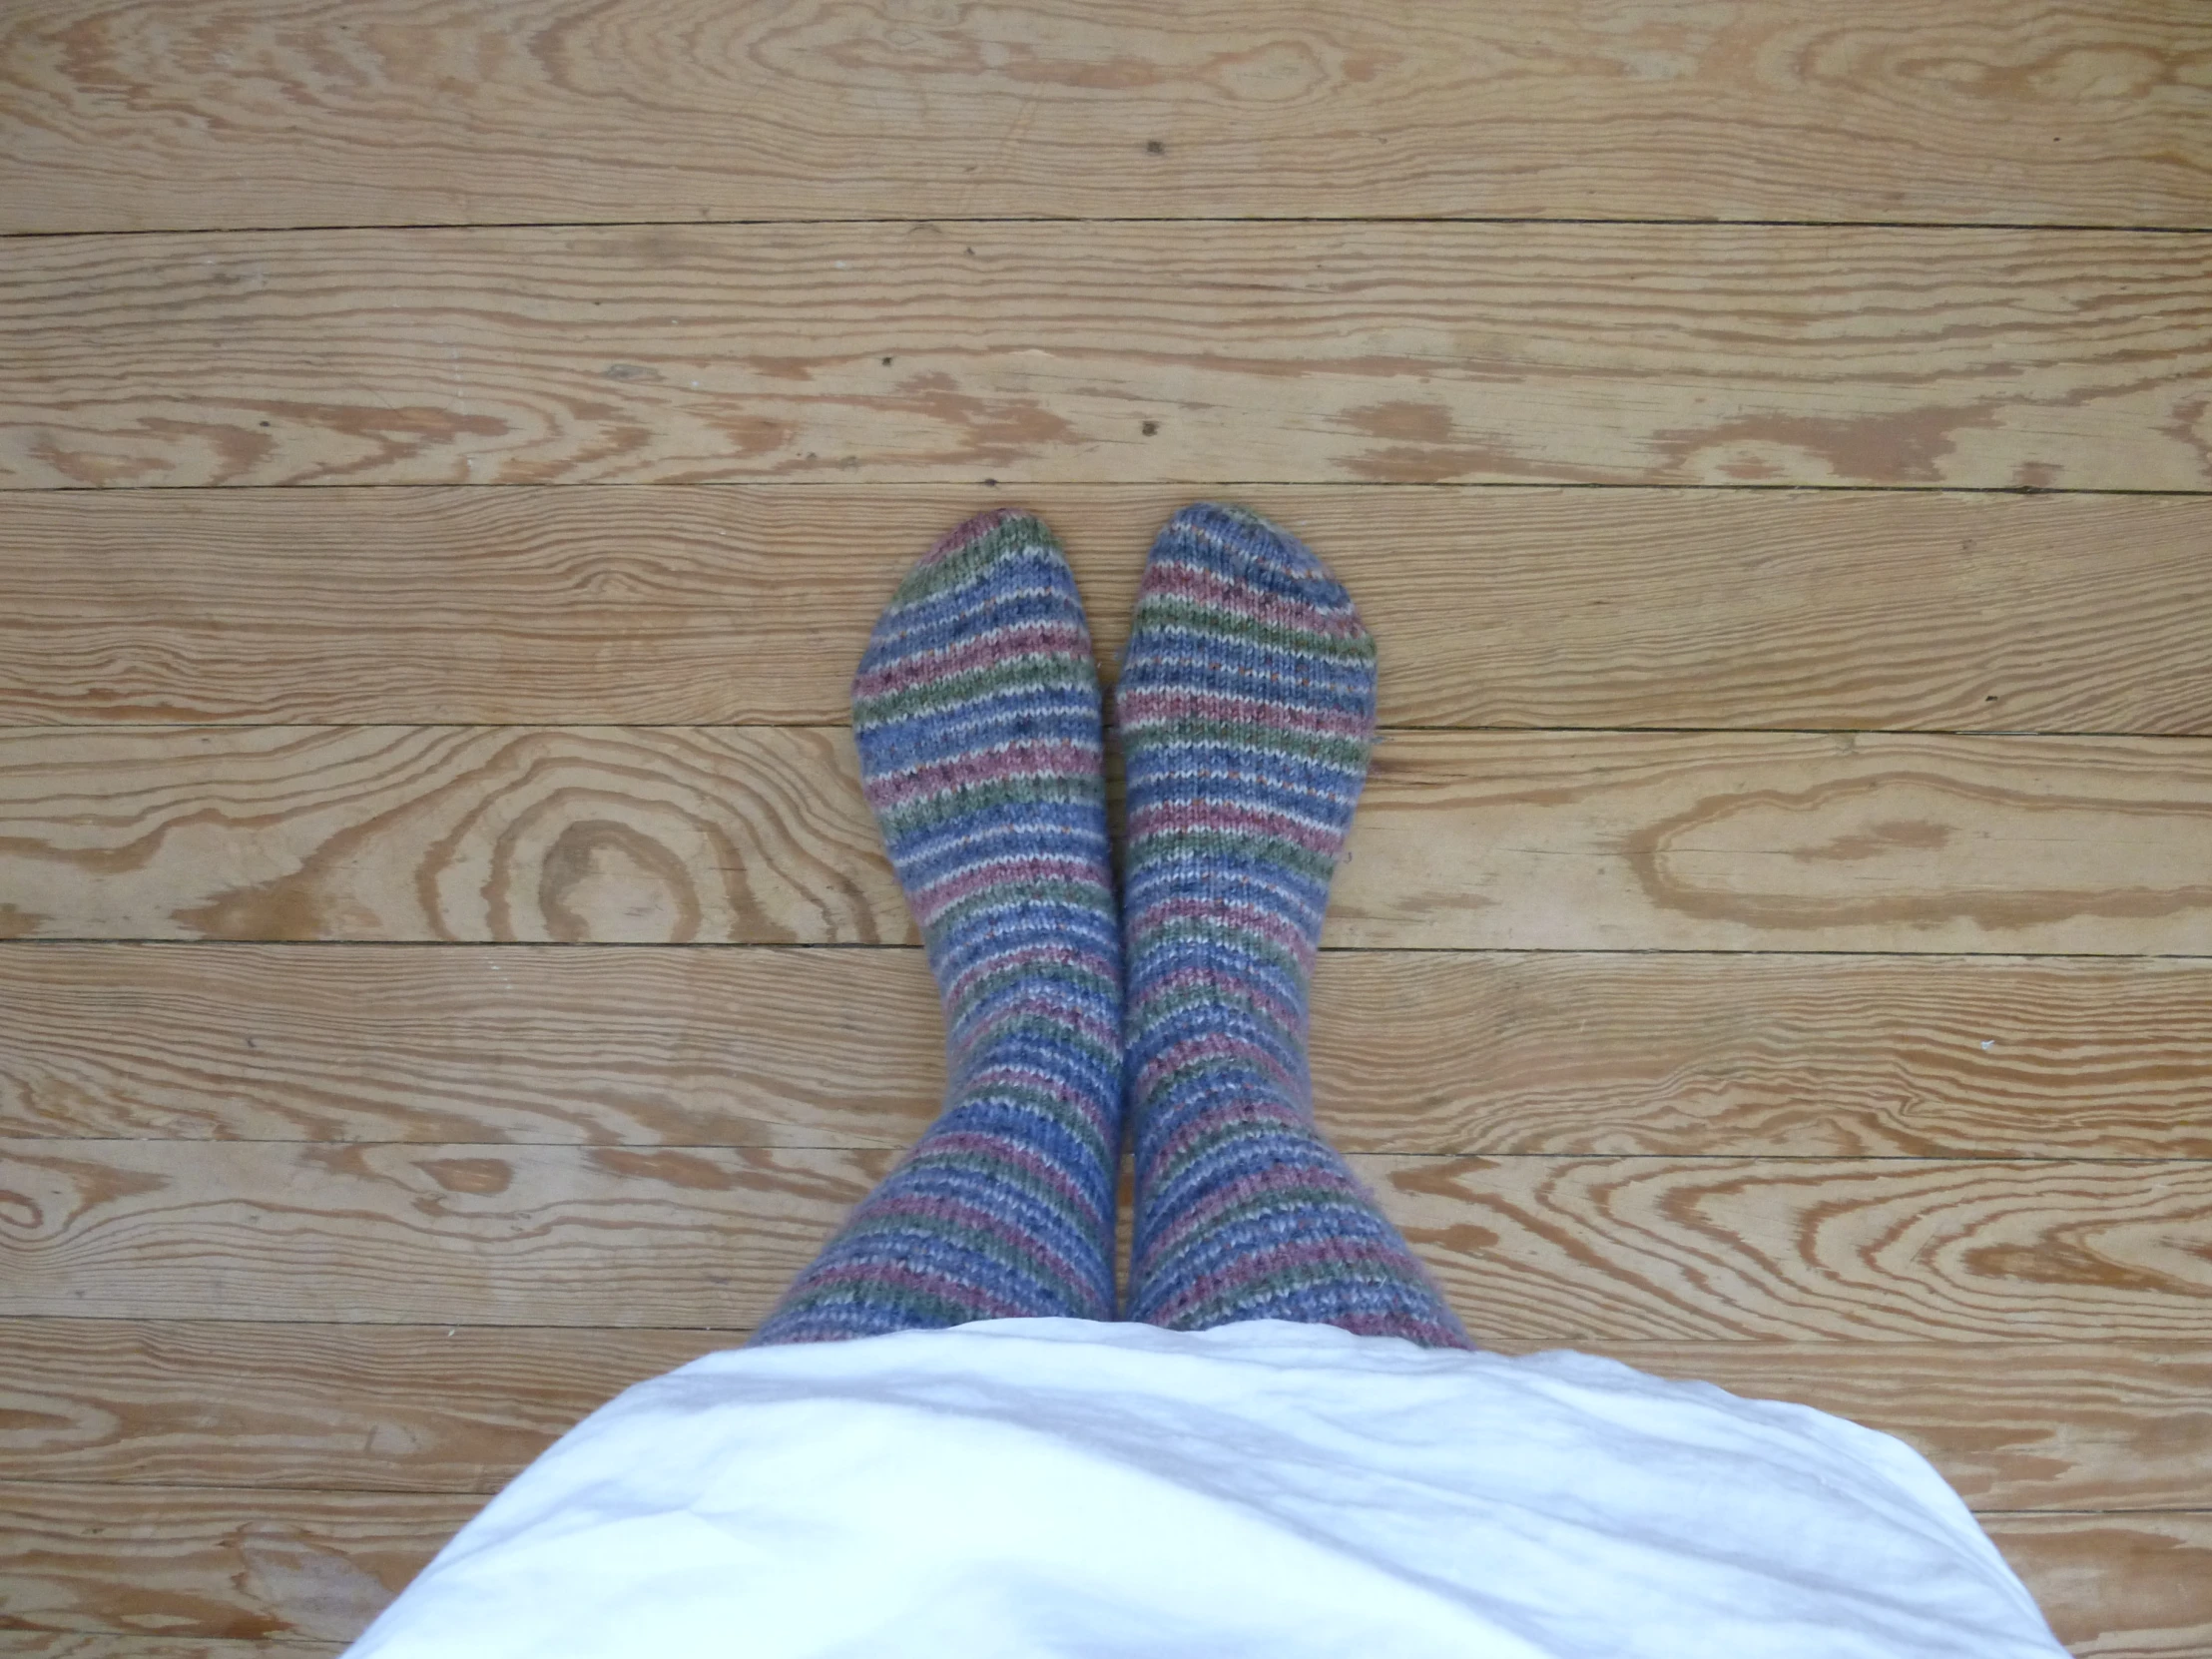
xmin=0 ymin=0 xmax=2212 ymax=1659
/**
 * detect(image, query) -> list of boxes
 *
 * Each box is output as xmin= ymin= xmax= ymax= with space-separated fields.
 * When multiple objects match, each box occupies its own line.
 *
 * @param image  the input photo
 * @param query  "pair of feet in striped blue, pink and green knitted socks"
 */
xmin=755 ymin=506 xmax=1466 ymax=1345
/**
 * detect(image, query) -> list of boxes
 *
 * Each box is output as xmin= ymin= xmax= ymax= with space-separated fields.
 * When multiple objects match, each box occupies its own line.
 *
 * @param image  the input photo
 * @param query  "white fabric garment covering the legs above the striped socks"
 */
xmin=351 ymin=1319 xmax=2064 ymax=1659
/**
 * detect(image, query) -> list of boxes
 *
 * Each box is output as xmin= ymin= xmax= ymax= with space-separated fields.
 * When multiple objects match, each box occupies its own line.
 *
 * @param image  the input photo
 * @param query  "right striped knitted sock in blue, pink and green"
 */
xmin=1115 ymin=506 xmax=1471 ymax=1348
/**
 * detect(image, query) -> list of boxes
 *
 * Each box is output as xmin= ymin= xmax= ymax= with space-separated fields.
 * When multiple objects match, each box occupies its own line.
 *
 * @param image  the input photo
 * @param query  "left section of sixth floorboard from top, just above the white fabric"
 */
xmin=0 ymin=1139 xmax=879 ymax=1334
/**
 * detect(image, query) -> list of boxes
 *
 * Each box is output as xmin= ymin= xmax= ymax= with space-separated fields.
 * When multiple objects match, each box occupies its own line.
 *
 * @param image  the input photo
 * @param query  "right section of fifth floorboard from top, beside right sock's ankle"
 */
xmin=1301 ymin=946 xmax=2212 ymax=1157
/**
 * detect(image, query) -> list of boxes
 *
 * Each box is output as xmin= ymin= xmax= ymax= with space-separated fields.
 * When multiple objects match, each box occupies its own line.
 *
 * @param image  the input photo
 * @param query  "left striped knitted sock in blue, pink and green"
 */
xmin=752 ymin=511 xmax=1122 ymax=1343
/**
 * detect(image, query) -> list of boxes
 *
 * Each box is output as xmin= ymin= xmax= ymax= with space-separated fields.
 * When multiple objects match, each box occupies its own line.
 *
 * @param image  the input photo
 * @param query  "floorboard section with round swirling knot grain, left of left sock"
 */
xmin=0 ymin=728 xmax=911 ymax=942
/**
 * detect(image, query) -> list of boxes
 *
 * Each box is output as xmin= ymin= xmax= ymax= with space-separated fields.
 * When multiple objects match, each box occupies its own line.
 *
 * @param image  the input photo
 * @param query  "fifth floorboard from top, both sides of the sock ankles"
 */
xmin=17 ymin=942 xmax=2212 ymax=1157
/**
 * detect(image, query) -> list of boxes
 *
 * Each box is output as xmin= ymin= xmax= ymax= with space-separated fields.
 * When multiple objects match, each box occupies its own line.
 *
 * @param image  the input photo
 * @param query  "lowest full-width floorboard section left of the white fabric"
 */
xmin=0 ymin=1484 xmax=466 ymax=1659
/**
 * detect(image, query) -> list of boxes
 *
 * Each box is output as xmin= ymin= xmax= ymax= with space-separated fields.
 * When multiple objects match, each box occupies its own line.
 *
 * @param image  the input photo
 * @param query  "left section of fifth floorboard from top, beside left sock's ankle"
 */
xmin=0 ymin=944 xmax=942 ymax=1148
